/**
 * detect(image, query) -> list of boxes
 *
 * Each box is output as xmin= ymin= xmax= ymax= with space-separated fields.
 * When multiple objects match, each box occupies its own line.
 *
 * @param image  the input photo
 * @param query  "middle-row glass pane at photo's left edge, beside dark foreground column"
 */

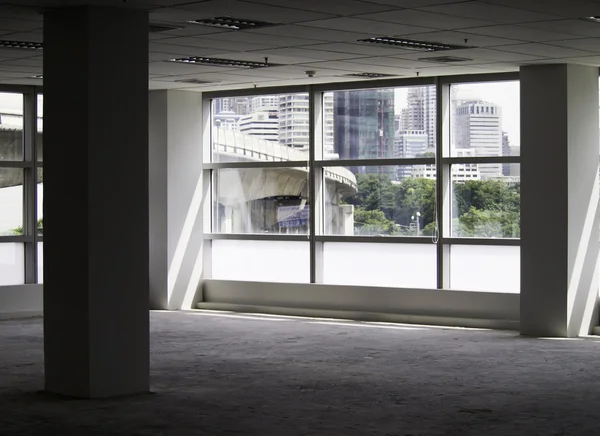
xmin=0 ymin=168 xmax=23 ymax=236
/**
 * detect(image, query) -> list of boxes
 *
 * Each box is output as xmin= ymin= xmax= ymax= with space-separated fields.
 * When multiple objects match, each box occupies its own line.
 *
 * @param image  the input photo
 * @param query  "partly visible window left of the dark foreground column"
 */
xmin=0 ymin=87 xmax=43 ymax=286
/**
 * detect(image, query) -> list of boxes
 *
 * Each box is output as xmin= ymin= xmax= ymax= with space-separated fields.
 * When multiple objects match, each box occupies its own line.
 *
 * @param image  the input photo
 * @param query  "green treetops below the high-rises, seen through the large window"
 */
xmin=344 ymin=174 xmax=521 ymax=238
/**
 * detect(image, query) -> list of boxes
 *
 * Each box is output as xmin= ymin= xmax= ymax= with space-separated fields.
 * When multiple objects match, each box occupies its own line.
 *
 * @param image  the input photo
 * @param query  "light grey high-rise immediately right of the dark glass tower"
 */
xmin=399 ymin=86 xmax=437 ymax=148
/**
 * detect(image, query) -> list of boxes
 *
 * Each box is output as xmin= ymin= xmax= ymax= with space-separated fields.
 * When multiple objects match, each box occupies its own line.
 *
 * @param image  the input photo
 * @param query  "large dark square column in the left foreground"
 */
xmin=44 ymin=7 xmax=149 ymax=398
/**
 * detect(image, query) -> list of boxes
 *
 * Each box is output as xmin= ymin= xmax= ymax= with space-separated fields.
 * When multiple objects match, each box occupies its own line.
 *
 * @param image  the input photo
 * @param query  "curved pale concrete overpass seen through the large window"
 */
xmin=213 ymin=127 xmax=357 ymax=235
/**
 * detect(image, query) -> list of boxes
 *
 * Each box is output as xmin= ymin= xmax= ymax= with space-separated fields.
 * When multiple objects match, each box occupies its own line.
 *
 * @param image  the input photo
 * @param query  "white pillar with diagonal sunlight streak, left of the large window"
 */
xmin=150 ymin=90 xmax=204 ymax=310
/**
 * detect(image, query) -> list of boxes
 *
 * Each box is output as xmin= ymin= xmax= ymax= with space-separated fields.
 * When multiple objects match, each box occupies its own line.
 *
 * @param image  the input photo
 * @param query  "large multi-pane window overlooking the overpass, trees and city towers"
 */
xmin=204 ymin=75 xmax=520 ymax=292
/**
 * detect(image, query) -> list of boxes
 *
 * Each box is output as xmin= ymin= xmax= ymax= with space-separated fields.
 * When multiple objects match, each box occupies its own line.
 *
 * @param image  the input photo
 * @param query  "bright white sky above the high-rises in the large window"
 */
xmin=395 ymin=81 xmax=521 ymax=146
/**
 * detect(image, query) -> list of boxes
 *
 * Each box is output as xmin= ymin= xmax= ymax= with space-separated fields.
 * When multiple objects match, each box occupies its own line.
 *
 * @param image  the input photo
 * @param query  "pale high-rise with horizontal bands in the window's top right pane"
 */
xmin=452 ymin=100 xmax=503 ymax=178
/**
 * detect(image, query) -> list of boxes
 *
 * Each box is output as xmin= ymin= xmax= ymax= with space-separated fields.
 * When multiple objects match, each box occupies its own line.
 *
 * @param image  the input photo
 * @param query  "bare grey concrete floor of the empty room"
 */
xmin=0 ymin=312 xmax=600 ymax=436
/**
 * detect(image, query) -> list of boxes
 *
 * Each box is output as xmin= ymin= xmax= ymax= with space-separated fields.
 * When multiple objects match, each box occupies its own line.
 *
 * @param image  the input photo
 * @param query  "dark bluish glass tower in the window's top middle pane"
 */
xmin=334 ymin=89 xmax=394 ymax=164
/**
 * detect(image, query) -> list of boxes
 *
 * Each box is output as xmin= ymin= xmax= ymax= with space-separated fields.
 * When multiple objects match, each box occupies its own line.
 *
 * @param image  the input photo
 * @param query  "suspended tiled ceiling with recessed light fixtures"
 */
xmin=0 ymin=0 xmax=600 ymax=91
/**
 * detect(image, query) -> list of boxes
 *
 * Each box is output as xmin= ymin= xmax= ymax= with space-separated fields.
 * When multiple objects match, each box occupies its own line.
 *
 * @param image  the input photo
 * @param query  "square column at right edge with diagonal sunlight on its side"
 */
xmin=520 ymin=65 xmax=600 ymax=337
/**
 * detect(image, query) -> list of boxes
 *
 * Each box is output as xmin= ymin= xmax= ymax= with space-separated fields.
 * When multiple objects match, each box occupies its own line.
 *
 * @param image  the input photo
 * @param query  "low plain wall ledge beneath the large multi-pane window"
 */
xmin=198 ymin=279 xmax=519 ymax=330
